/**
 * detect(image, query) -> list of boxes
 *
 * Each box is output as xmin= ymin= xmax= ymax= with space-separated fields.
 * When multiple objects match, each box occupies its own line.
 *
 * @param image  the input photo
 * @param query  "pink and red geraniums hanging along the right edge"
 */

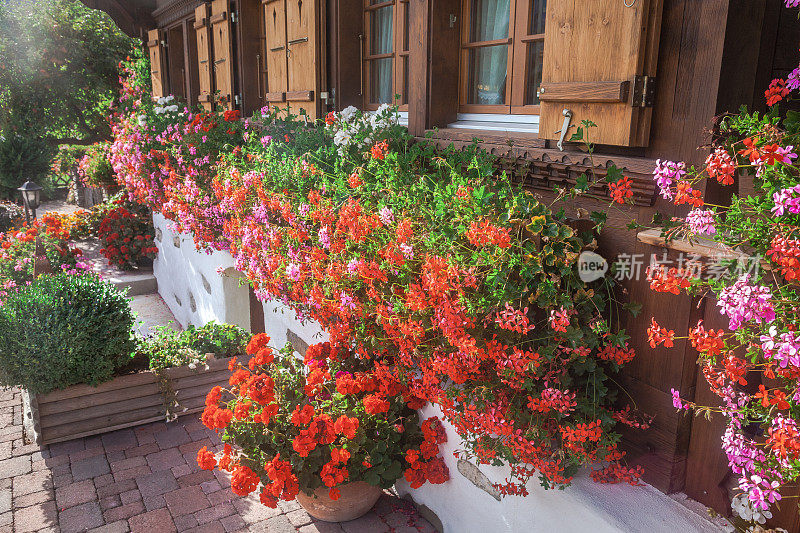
xmin=648 ymin=0 xmax=800 ymax=524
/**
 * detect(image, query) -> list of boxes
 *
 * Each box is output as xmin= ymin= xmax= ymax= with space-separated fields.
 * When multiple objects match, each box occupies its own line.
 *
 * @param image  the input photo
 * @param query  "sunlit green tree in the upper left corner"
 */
xmin=0 ymin=0 xmax=141 ymax=195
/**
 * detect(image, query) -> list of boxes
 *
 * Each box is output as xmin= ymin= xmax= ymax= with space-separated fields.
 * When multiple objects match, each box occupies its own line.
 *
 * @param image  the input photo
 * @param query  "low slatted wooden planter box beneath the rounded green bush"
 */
xmin=23 ymin=357 xmax=231 ymax=445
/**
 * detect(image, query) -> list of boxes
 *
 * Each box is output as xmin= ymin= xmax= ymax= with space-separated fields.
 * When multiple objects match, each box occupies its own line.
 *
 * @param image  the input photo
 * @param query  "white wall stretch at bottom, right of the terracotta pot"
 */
xmin=396 ymin=406 xmax=726 ymax=533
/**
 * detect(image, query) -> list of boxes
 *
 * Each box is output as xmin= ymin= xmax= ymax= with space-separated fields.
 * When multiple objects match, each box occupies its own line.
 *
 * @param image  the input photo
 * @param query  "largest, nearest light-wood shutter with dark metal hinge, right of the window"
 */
xmin=539 ymin=0 xmax=663 ymax=146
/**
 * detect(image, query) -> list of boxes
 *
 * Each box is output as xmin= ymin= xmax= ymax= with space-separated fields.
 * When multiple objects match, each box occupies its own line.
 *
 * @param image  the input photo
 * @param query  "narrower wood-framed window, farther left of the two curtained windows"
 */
xmin=361 ymin=0 xmax=408 ymax=109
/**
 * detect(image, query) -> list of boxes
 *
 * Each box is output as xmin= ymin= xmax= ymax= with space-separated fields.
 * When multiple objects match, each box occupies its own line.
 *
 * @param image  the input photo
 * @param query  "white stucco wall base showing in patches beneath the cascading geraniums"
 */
xmin=153 ymin=215 xmax=725 ymax=533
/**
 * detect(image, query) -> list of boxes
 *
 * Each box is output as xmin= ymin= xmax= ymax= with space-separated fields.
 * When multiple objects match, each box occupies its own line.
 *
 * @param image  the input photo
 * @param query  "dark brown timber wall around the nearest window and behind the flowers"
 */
xmin=331 ymin=0 xmax=800 ymax=531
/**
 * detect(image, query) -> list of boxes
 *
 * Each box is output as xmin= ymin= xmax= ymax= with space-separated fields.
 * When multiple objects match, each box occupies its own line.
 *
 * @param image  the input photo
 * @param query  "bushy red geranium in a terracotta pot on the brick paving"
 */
xmin=197 ymin=333 xmax=448 ymax=522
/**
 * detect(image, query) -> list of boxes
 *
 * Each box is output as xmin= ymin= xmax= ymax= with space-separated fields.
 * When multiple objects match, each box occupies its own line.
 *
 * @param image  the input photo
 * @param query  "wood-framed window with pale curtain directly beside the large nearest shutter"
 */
xmin=459 ymin=0 xmax=547 ymax=114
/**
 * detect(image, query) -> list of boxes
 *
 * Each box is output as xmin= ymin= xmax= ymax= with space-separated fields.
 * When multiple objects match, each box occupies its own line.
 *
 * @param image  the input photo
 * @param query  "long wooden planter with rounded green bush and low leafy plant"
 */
xmin=0 ymin=271 xmax=249 ymax=444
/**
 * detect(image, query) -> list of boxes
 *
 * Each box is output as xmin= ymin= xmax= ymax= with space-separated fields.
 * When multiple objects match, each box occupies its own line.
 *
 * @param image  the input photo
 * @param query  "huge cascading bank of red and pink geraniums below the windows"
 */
xmin=111 ymin=52 xmax=646 ymax=501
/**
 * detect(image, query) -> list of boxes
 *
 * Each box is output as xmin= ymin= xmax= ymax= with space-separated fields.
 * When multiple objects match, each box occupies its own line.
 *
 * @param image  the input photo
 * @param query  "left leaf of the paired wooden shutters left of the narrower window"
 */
xmin=262 ymin=0 xmax=289 ymax=104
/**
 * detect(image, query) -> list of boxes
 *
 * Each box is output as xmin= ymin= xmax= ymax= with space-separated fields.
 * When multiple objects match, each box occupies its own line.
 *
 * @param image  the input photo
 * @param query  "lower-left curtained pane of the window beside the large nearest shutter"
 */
xmin=467 ymin=44 xmax=508 ymax=105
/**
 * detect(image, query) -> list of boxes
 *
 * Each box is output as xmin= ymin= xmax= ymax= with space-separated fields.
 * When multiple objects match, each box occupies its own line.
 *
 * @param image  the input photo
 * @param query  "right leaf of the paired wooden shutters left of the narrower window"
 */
xmin=286 ymin=0 xmax=325 ymax=120
